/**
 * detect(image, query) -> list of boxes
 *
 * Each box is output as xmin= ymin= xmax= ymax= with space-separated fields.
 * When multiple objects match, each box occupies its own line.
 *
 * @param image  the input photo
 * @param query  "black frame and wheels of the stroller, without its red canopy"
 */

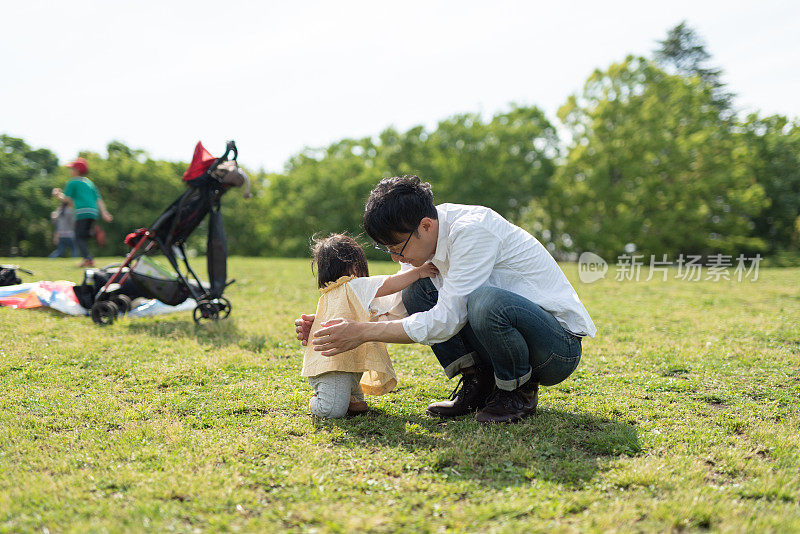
xmin=91 ymin=141 xmax=241 ymax=326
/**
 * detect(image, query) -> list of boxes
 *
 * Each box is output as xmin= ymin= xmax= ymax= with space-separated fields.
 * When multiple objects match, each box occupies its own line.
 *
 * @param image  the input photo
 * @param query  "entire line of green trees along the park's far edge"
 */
xmin=0 ymin=23 xmax=800 ymax=259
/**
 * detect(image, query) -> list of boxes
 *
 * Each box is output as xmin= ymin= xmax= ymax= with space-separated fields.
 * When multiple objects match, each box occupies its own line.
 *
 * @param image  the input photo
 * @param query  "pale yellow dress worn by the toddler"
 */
xmin=301 ymin=276 xmax=397 ymax=395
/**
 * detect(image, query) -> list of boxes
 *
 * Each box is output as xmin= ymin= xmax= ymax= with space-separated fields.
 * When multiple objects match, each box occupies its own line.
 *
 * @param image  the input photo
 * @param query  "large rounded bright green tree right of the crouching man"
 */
xmin=529 ymin=56 xmax=768 ymax=258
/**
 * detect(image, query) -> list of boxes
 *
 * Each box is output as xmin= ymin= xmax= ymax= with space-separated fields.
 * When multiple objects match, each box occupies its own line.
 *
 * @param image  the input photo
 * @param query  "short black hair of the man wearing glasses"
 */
xmin=364 ymin=174 xmax=439 ymax=246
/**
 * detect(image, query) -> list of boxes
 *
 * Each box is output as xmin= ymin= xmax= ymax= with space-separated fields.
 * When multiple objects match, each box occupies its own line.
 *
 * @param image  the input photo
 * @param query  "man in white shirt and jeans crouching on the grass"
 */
xmin=295 ymin=176 xmax=597 ymax=423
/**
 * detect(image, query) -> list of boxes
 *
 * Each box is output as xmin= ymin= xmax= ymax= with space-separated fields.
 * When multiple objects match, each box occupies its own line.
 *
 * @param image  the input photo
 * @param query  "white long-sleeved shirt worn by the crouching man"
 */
xmin=403 ymin=204 xmax=597 ymax=345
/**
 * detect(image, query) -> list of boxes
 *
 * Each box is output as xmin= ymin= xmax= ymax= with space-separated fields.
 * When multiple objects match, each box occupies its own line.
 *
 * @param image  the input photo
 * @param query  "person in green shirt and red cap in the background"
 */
xmin=53 ymin=158 xmax=114 ymax=267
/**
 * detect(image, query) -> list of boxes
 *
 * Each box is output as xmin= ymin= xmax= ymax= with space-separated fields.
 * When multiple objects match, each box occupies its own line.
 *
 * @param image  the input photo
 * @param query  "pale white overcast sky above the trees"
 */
xmin=0 ymin=0 xmax=800 ymax=171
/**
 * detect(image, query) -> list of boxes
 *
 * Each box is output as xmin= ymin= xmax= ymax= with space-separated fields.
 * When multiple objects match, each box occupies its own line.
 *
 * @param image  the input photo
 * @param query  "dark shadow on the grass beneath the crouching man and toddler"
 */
xmin=322 ymin=409 xmax=641 ymax=487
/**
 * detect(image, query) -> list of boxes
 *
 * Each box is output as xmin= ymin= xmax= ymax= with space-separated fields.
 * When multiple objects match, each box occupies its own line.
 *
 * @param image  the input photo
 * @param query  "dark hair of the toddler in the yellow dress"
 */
xmin=311 ymin=234 xmax=369 ymax=288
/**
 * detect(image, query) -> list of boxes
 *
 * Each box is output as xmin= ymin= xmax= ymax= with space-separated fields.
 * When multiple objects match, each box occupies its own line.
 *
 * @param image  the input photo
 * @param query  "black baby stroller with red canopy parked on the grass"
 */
xmin=91 ymin=141 xmax=250 ymax=326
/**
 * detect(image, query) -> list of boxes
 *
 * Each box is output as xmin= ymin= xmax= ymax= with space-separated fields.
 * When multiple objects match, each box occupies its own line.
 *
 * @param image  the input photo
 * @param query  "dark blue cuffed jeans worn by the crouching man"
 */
xmin=403 ymin=278 xmax=582 ymax=391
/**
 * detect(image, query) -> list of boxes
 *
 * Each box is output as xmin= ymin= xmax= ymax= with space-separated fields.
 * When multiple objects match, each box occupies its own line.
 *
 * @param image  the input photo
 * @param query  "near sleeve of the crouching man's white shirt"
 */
xmin=403 ymin=224 xmax=500 ymax=345
